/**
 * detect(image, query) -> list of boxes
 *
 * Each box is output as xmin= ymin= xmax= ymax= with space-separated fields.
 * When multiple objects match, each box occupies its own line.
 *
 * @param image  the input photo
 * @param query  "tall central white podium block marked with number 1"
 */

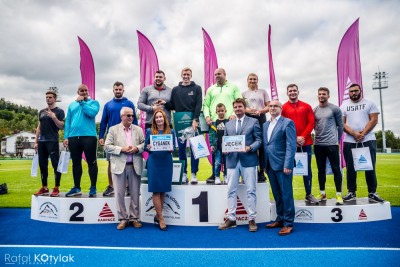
xmin=141 ymin=183 xmax=270 ymax=226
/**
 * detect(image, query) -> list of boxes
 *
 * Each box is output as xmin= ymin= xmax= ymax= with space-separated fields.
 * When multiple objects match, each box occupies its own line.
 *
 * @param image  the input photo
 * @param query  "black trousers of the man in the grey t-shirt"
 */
xmin=314 ymin=145 xmax=342 ymax=192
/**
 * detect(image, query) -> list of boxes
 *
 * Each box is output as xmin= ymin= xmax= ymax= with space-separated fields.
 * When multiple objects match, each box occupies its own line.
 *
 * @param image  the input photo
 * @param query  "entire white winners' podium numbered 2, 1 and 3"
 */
xmin=31 ymin=183 xmax=392 ymax=226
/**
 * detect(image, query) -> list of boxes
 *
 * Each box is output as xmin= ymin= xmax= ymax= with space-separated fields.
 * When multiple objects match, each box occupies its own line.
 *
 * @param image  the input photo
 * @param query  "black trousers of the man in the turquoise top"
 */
xmin=68 ymin=136 xmax=98 ymax=188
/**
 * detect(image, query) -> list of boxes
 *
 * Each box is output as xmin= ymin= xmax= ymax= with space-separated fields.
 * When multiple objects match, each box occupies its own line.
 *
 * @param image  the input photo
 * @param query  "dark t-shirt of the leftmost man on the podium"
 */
xmin=38 ymin=107 xmax=65 ymax=142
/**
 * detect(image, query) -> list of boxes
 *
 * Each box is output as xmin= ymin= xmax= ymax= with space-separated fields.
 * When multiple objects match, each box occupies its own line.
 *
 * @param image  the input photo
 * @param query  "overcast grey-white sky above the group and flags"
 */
xmin=0 ymin=0 xmax=400 ymax=134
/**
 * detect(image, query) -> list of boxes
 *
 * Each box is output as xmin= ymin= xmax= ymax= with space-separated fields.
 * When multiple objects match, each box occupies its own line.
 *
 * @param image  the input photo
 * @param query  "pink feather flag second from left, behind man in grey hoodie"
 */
xmin=136 ymin=31 xmax=159 ymax=159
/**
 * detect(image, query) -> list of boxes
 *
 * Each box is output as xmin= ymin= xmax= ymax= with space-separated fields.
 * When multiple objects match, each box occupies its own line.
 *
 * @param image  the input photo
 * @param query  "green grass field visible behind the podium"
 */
xmin=0 ymin=154 xmax=400 ymax=208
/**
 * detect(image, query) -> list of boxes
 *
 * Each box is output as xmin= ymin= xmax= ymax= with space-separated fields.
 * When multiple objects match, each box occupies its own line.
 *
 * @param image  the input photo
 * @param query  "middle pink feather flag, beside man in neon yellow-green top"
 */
xmin=202 ymin=28 xmax=218 ymax=164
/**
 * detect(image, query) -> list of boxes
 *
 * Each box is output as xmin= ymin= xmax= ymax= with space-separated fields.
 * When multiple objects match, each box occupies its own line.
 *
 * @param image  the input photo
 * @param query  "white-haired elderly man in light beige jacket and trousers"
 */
xmin=104 ymin=107 xmax=144 ymax=230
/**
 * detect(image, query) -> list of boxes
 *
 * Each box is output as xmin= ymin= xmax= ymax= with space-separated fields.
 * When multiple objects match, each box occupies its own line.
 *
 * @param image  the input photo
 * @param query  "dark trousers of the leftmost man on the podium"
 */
xmin=38 ymin=141 xmax=61 ymax=186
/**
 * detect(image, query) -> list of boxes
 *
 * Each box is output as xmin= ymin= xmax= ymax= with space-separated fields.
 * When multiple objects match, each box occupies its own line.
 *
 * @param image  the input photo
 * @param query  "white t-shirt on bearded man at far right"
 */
xmin=340 ymin=98 xmax=380 ymax=143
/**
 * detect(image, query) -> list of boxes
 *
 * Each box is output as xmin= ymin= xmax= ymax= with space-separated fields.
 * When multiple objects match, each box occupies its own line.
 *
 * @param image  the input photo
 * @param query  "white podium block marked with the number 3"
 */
xmin=271 ymin=198 xmax=392 ymax=223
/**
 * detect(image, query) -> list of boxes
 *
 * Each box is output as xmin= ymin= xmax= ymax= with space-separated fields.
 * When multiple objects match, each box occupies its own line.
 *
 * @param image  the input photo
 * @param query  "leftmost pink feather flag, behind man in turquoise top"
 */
xmin=78 ymin=36 xmax=96 ymax=99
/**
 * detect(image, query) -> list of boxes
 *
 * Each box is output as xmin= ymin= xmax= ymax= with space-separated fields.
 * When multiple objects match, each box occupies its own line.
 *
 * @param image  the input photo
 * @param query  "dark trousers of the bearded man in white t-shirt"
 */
xmin=343 ymin=140 xmax=377 ymax=193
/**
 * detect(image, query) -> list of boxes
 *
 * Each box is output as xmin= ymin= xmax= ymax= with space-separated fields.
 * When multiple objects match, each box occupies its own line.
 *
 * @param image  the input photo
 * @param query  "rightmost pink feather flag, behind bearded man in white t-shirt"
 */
xmin=337 ymin=18 xmax=362 ymax=167
